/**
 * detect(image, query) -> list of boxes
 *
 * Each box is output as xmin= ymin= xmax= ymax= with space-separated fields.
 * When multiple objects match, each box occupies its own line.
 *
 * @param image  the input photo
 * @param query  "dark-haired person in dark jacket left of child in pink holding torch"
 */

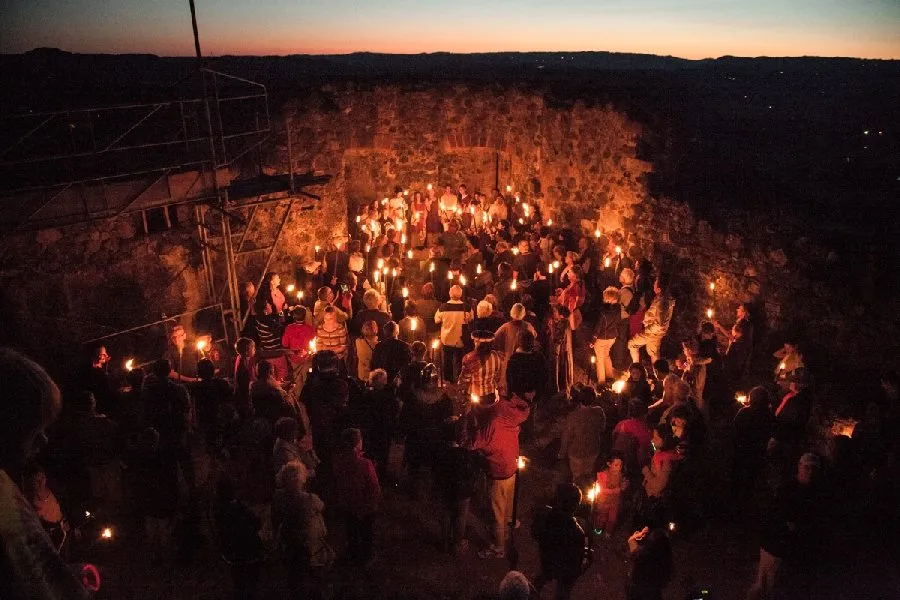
xmin=531 ymin=483 xmax=590 ymax=600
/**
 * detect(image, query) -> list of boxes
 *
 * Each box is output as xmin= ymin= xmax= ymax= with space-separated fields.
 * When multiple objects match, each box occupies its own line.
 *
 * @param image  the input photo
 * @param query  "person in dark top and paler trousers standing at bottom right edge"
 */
xmin=747 ymin=452 xmax=827 ymax=600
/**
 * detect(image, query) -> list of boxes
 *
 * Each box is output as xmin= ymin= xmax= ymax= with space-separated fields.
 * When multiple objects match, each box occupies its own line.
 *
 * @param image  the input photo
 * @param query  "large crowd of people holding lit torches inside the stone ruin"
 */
xmin=0 ymin=186 xmax=900 ymax=600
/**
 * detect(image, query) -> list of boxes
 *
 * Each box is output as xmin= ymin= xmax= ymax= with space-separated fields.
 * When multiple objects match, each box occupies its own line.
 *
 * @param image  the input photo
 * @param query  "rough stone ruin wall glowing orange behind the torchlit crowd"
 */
xmin=0 ymin=86 xmax=897 ymax=396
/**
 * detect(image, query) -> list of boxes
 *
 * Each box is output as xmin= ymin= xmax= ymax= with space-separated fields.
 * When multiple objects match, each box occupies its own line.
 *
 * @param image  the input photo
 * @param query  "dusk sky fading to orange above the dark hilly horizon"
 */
xmin=0 ymin=0 xmax=900 ymax=59
